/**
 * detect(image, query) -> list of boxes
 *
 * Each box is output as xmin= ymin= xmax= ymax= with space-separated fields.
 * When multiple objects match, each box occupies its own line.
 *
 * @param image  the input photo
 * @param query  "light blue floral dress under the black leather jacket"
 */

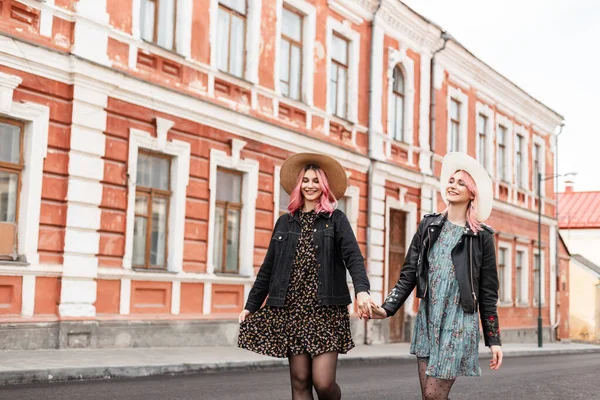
xmin=410 ymin=221 xmax=481 ymax=379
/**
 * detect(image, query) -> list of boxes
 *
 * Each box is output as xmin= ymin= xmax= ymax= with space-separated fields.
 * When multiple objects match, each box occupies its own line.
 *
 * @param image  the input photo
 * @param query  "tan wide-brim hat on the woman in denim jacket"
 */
xmin=279 ymin=153 xmax=348 ymax=199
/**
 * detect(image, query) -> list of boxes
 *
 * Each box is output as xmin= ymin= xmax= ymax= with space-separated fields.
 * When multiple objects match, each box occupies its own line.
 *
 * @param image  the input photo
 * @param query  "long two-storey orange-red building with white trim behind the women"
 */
xmin=0 ymin=0 xmax=563 ymax=348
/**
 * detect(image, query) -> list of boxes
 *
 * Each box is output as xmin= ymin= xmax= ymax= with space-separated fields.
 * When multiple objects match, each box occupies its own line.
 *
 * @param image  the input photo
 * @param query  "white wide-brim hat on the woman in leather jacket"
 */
xmin=440 ymin=152 xmax=494 ymax=222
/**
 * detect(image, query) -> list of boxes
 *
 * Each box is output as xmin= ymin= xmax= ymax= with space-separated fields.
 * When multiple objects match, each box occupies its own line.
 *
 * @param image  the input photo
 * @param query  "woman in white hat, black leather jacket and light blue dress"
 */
xmin=373 ymin=152 xmax=502 ymax=400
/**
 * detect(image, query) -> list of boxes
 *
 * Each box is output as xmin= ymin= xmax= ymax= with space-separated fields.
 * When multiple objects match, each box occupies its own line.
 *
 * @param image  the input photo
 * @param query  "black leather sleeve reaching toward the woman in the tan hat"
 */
xmin=382 ymin=219 xmax=425 ymax=317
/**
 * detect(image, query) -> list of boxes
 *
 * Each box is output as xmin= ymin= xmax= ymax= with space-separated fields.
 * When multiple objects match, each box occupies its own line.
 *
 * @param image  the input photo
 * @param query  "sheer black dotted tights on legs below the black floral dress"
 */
xmin=288 ymin=352 xmax=342 ymax=400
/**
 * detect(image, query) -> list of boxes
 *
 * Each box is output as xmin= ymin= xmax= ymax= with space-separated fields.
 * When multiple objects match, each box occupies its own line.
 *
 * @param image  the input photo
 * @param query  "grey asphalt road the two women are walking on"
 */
xmin=0 ymin=354 xmax=600 ymax=400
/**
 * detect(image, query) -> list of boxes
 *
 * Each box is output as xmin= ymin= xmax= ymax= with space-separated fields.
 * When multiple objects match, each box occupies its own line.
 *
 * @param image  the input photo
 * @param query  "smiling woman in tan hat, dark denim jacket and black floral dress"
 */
xmin=238 ymin=153 xmax=371 ymax=399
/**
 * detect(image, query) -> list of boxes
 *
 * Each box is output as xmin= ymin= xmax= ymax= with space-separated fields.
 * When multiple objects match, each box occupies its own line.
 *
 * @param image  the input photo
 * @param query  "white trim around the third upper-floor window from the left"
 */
xmin=273 ymin=0 xmax=317 ymax=106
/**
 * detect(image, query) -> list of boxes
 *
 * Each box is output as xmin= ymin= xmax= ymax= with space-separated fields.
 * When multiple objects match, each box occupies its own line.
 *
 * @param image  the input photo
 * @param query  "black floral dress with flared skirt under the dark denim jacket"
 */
xmin=238 ymin=211 xmax=354 ymax=358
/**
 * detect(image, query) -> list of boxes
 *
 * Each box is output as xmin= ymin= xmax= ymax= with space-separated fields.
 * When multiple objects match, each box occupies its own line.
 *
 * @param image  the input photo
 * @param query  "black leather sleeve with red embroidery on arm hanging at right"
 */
xmin=479 ymin=234 xmax=502 ymax=346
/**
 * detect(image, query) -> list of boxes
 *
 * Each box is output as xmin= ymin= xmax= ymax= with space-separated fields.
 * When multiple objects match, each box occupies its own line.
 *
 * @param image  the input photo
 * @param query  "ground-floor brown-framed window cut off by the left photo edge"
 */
xmin=0 ymin=119 xmax=23 ymax=223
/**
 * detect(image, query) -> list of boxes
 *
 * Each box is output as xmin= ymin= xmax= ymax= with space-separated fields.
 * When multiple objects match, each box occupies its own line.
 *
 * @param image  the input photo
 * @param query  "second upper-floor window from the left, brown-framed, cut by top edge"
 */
xmin=216 ymin=0 xmax=247 ymax=78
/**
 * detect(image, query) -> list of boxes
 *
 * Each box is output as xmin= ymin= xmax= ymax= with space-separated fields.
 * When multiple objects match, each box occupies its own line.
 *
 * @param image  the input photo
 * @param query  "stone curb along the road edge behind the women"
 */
xmin=0 ymin=347 xmax=600 ymax=386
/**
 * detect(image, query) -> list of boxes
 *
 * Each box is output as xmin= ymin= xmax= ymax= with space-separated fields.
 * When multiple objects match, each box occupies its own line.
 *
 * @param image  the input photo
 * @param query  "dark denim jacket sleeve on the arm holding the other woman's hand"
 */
xmin=334 ymin=211 xmax=371 ymax=294
